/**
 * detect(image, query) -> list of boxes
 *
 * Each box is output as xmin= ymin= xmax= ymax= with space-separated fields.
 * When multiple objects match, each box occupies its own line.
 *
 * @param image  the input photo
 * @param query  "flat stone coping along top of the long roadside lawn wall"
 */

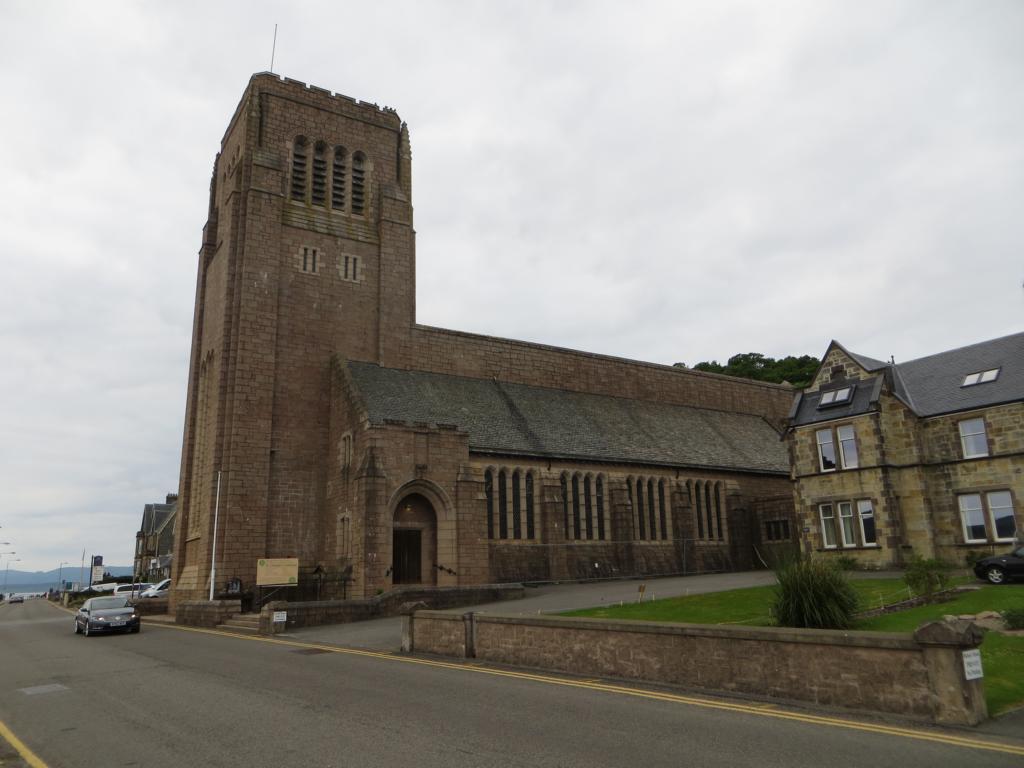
xmin=423 ymin=610 xmax=921 ymax=650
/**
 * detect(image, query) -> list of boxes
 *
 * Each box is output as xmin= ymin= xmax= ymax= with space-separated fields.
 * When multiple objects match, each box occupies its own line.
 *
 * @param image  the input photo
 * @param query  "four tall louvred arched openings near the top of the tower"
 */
xmin=289 ymin=136 xmax=367 ymax=216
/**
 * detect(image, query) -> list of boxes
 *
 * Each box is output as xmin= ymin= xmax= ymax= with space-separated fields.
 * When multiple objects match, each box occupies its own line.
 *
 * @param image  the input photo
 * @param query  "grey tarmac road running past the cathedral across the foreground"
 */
xmin=0 ymin=600 xmax=1024 ymax=768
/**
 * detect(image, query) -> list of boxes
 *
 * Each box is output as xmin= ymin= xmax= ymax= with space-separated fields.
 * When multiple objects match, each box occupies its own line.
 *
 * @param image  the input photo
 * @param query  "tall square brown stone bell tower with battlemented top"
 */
xmin=173 ymin=73 xmax=416 ymax=602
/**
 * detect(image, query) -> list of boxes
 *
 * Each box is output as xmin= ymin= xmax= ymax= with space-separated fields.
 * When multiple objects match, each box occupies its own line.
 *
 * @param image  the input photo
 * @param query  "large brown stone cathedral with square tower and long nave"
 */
xmin=173 ymin=74 xmax=799 ymax=601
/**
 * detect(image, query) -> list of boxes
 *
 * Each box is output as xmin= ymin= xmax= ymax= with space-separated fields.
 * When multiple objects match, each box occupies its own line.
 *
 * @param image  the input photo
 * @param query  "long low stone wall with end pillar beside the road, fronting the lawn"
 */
xmin=402 ymin=610 xmax=987 ymax=725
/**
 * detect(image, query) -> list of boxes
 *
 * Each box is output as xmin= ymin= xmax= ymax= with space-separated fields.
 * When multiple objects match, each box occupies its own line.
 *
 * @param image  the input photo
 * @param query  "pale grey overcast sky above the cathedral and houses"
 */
xmin=0 ymin=0 xmax=1024 ymax=570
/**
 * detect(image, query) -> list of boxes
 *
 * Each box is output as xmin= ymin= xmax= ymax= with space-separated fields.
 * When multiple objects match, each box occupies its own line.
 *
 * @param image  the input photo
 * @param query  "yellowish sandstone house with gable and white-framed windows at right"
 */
xmin=787 ymin=334 xmax=1024 ymax=567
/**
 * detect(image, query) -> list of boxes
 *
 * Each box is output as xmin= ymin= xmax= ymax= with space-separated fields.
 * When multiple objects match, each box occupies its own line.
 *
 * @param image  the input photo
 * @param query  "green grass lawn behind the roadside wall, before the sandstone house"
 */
xmin=564 ymin=579 xmax=1024 ymax=715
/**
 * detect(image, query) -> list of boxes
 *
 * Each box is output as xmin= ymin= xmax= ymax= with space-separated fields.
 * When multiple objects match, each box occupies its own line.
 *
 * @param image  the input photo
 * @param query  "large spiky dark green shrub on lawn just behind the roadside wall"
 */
xmin=771 ymin=560 xmax=857 ymax=630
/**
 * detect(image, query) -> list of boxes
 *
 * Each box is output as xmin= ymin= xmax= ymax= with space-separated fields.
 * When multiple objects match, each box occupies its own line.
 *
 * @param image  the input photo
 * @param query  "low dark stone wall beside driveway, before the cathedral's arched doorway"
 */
xmin=252 ymin=584 xmax=523 ymax=635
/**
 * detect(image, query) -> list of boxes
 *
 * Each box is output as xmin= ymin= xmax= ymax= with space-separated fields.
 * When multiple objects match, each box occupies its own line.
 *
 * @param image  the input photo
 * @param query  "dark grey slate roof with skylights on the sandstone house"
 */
xmin=791 ymin=333 xmax=1024 ymax=426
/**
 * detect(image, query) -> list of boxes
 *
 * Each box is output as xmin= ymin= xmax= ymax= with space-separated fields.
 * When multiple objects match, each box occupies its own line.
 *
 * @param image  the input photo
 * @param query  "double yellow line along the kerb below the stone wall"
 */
xmin=148 ymin=623 xmax=1024 ymax=756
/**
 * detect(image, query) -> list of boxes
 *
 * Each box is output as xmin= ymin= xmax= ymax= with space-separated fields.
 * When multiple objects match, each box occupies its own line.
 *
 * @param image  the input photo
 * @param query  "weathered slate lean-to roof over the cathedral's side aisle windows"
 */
xmin=346 ymin=361 xmax=788 ymax=473
